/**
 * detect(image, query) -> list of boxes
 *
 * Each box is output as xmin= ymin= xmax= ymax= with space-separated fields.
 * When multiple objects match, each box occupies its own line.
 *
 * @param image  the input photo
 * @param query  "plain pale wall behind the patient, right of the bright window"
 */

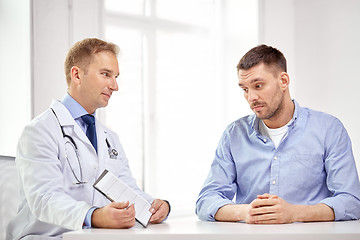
xmin=260 ymin=0 xmax=360 ymax=172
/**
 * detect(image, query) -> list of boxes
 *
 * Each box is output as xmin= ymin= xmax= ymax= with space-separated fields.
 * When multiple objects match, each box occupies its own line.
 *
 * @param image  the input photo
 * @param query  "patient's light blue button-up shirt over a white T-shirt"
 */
xmin=196 ymin=101 xmax=360 ymax=221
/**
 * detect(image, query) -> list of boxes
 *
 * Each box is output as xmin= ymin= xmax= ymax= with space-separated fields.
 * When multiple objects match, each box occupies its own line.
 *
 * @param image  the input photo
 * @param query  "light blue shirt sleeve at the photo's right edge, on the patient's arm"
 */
xmin=321 ymin=119 xmax=360 ymax=221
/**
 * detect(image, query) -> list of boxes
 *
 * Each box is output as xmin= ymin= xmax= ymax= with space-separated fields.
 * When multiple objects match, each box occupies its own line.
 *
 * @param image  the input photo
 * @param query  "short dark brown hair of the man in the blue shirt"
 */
xmin=236 ymin=44 xmax=287 ymax=72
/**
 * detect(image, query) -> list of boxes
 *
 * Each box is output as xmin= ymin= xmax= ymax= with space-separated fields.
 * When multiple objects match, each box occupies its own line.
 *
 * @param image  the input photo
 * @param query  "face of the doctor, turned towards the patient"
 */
xmin=73 ymin=51 xmax=119 ymax=113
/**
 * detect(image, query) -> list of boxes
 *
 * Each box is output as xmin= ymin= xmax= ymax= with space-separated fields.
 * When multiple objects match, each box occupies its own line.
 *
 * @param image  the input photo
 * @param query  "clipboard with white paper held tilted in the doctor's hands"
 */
xmin=93 ymin=169 xmax=152 ymax=227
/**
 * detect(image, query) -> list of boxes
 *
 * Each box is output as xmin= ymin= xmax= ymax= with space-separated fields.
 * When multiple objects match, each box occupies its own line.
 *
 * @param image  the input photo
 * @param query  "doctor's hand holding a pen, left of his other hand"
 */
xmin=91 ymin=201 xmax=135 ymax=228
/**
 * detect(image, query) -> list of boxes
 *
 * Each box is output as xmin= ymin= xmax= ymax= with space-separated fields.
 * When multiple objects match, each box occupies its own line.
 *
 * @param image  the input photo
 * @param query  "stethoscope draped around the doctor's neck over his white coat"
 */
xmin=51 ymin=108 xmax=119 ymax=185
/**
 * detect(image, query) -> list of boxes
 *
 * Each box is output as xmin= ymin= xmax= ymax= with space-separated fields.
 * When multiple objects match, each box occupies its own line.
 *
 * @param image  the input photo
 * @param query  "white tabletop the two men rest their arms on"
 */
xmin=63 ymin=217 xmax=360 ymax=240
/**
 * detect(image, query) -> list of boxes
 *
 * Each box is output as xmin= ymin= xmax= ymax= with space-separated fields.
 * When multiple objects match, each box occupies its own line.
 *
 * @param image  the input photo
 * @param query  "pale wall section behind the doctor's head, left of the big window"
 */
xmin=32 ymin=0 xmax=102 ymax=117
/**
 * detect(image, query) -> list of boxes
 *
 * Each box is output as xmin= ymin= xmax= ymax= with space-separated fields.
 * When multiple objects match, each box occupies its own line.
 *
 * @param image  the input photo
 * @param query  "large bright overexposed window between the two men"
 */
xmin=102 ymin=0 xmax=257 ymax=215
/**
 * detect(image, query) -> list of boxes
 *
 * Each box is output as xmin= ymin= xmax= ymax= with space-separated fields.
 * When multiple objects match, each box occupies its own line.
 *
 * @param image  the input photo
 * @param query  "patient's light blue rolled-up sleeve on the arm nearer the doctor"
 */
xmin=196 ymin=127 xmax=236 ymax=221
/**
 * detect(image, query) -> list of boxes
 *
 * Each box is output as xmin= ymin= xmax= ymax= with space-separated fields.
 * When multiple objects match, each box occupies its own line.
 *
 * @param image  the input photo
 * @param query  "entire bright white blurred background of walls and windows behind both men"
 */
xmin=0 ymin=0 xmax=360 ymax=216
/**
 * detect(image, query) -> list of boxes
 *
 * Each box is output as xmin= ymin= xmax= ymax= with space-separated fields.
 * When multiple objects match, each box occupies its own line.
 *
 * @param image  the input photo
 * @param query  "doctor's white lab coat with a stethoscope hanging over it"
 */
xmin=7 ymin=101 xmax=153 ymax=239
